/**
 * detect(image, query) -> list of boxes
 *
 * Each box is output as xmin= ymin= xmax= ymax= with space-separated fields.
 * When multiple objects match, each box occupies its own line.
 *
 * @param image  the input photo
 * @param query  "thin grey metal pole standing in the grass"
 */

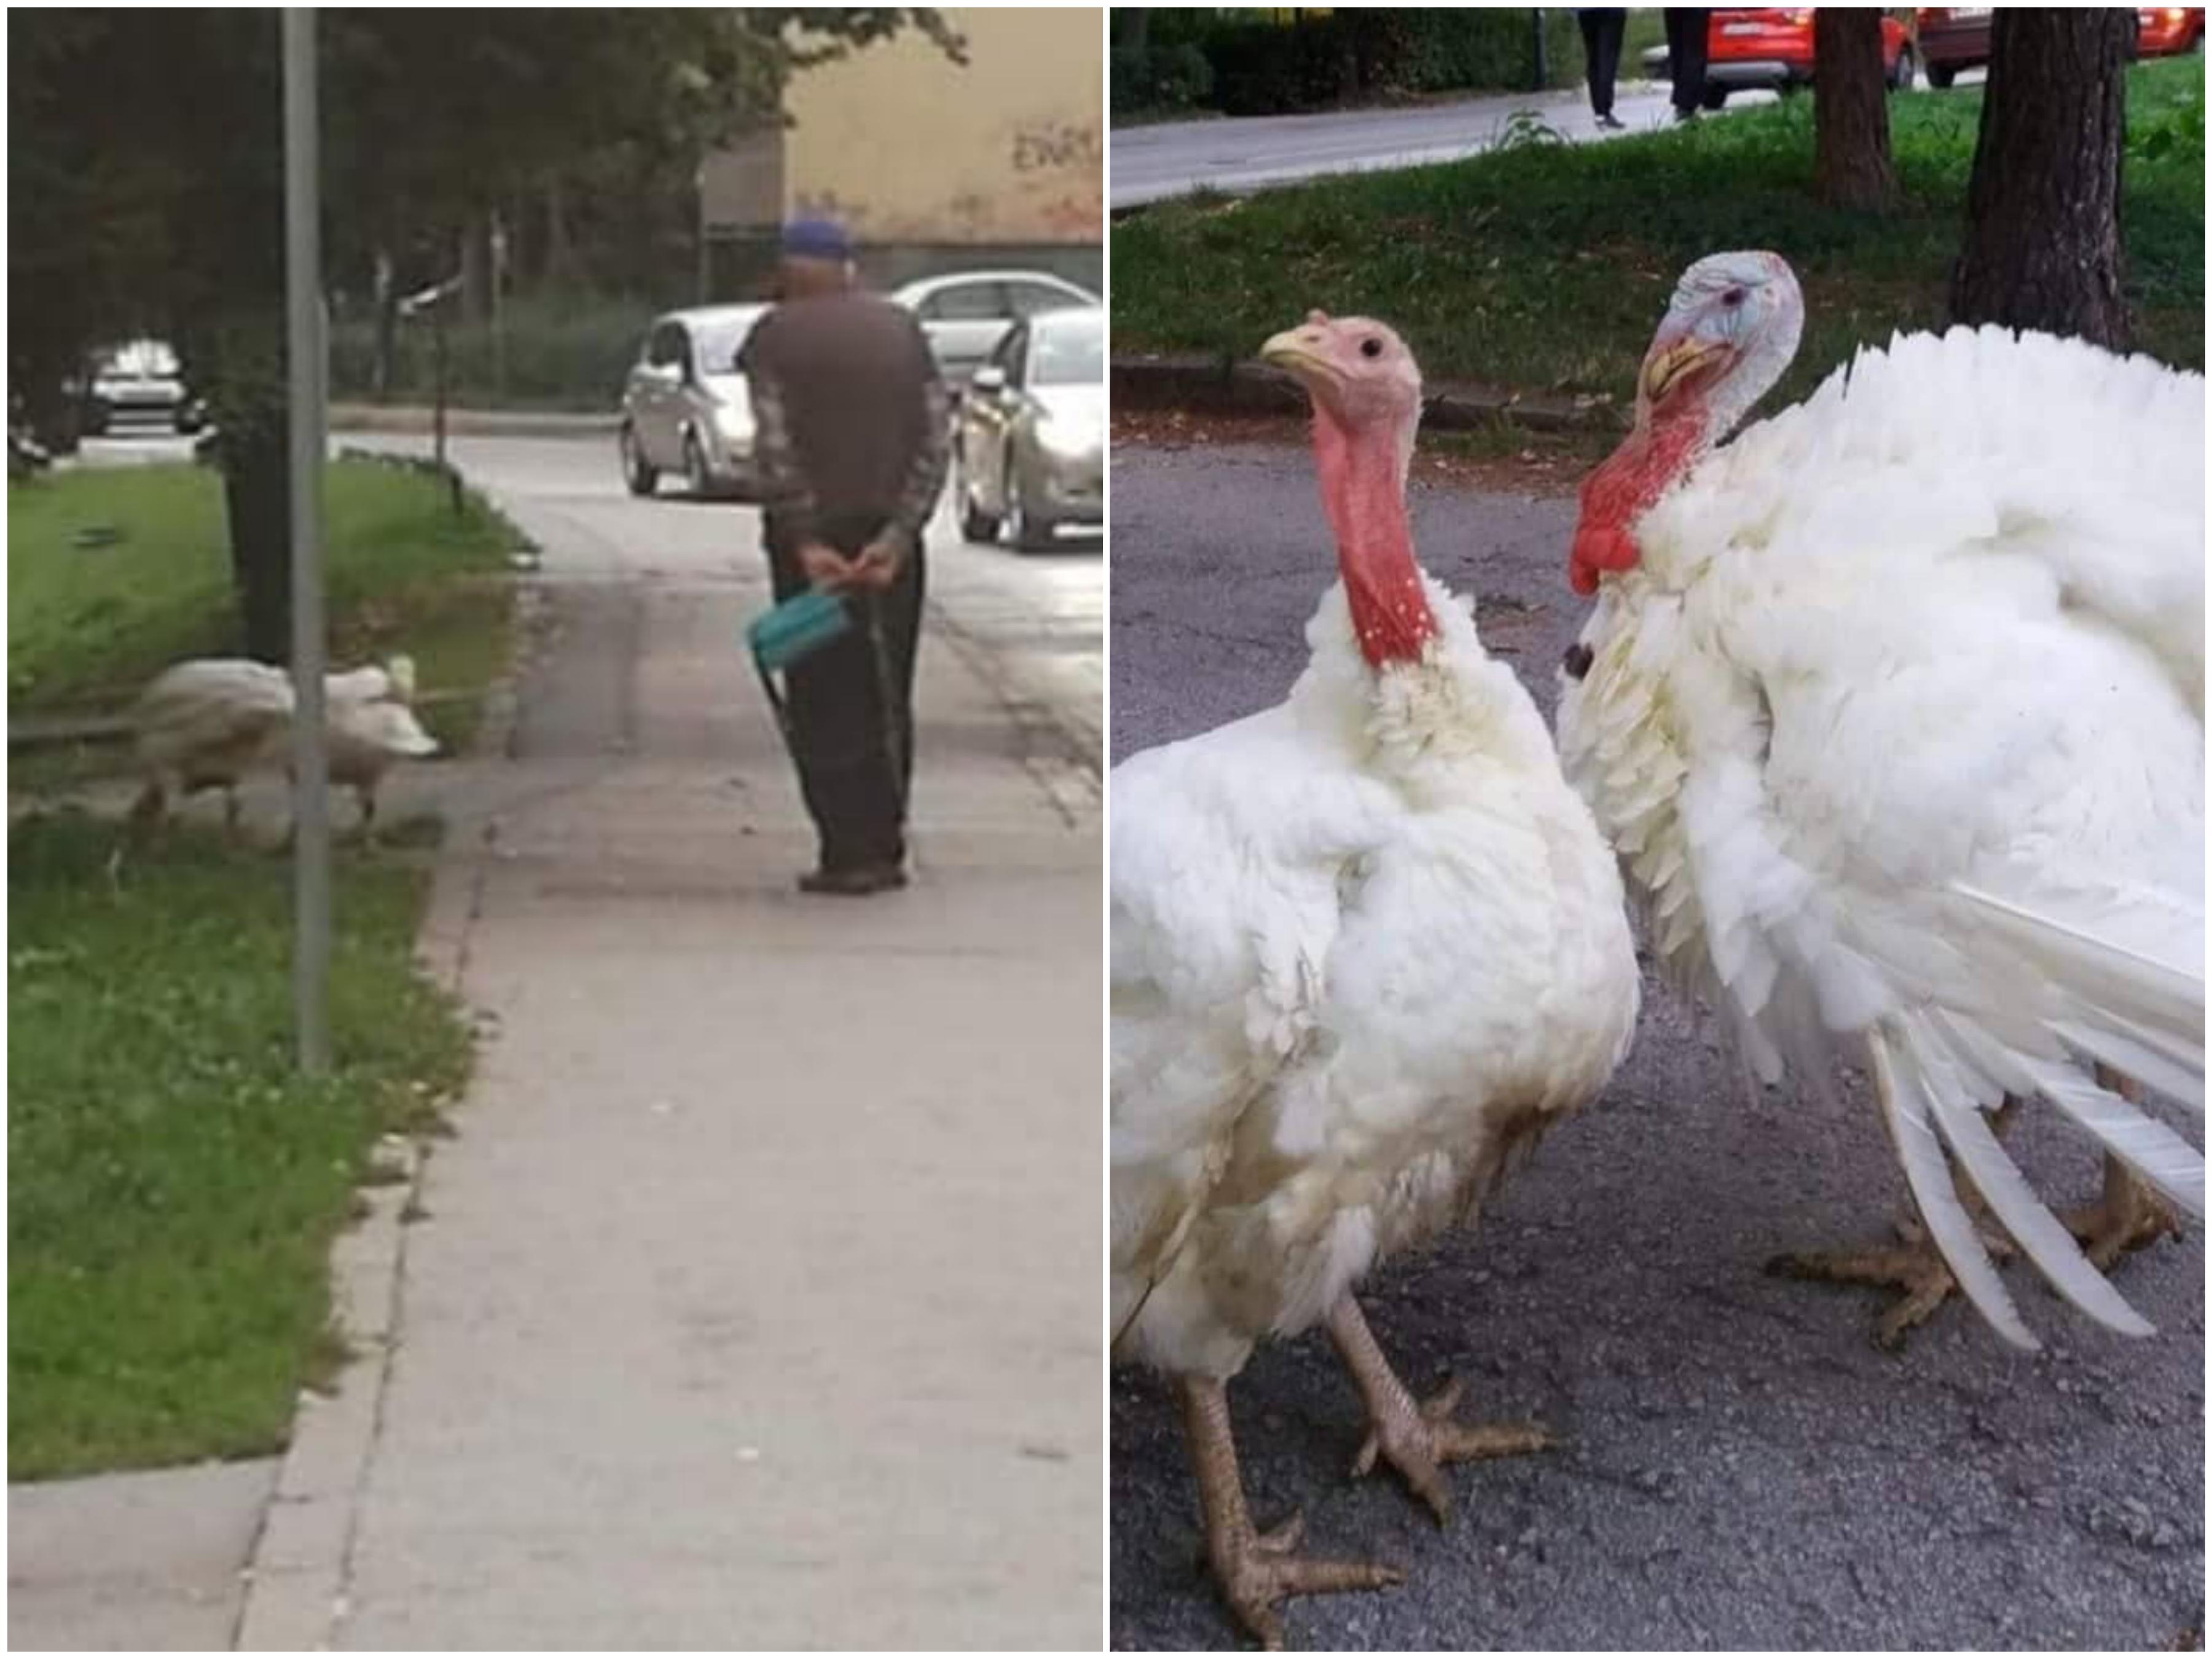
xmin=283 ymin=7 xmax=329 ymax=1077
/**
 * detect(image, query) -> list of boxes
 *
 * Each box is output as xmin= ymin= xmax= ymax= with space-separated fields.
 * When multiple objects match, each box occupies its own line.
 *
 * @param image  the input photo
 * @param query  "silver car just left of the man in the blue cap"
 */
xmin=615 ymin=305 xmax=767 ymax=500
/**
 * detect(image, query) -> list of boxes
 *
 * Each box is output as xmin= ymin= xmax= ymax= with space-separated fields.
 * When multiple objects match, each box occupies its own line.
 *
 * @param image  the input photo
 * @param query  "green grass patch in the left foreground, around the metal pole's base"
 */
xmin=7 ymin=816 xmax=469 ymax=1480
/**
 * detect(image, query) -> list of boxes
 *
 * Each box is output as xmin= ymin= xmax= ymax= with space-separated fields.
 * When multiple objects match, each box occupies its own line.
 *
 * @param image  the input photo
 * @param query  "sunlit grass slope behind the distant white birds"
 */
xmin=7 ymin=462 xmax=517 ymax=741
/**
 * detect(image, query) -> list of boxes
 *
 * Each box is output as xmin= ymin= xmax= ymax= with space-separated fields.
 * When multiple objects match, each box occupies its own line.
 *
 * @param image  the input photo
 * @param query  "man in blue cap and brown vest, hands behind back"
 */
xmin=739 ymin=219 xmax=949 ymax=893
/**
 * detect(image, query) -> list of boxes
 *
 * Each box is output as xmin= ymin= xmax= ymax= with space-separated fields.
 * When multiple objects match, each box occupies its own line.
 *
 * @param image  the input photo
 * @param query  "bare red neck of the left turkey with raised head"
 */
xmin=1314 ymin=402 xmax=1435 ymax=668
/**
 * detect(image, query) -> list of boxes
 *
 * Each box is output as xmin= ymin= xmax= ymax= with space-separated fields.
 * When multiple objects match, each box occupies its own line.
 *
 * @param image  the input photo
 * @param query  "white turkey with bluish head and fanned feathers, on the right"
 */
xmin=1559 ymin=252 xmax=2205 ymax=1347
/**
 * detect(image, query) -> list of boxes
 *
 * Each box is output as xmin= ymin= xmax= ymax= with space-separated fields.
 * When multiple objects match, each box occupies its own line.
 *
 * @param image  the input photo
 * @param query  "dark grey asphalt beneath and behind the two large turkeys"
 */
xmin=1108 ymin=437 xmax=2205 ymax=1650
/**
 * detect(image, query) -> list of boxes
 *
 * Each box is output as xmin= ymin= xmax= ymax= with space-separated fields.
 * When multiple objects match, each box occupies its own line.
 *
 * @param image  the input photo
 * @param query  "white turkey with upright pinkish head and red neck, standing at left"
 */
xmin=1108 ymin=312 xmax=1639 ymax=1645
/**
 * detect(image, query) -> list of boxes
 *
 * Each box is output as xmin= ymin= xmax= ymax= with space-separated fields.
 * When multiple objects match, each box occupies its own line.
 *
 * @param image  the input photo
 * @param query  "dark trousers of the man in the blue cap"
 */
xmin=766 ymin=517 xmax=922 ymax=869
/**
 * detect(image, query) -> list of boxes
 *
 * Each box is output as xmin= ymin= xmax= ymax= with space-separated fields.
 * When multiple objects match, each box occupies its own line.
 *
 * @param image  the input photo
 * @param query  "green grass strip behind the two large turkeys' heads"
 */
xmin=1113 ymin=58 xmax=2205 ymax=409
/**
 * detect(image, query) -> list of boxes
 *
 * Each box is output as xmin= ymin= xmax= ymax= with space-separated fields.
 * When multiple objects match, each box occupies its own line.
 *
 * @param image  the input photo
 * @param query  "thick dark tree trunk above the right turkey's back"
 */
xmin=1951 ymin=7 xmax=2135 ymax=351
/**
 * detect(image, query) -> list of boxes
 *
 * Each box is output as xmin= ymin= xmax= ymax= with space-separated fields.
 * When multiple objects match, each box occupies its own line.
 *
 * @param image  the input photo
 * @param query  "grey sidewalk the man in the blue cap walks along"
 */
xmin=239 ymin=473 xmax=1104 ymax=1648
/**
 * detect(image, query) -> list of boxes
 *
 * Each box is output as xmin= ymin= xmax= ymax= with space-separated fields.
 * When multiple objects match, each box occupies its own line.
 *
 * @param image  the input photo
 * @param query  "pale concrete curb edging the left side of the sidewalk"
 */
xmin=232 ymin=500 xmax=542 ymax=1652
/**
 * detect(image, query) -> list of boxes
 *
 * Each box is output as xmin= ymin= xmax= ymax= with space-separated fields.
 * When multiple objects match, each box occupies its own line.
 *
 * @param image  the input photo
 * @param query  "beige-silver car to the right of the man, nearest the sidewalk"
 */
xmin=954 ymin=305 xmax=1106 ymax=551
